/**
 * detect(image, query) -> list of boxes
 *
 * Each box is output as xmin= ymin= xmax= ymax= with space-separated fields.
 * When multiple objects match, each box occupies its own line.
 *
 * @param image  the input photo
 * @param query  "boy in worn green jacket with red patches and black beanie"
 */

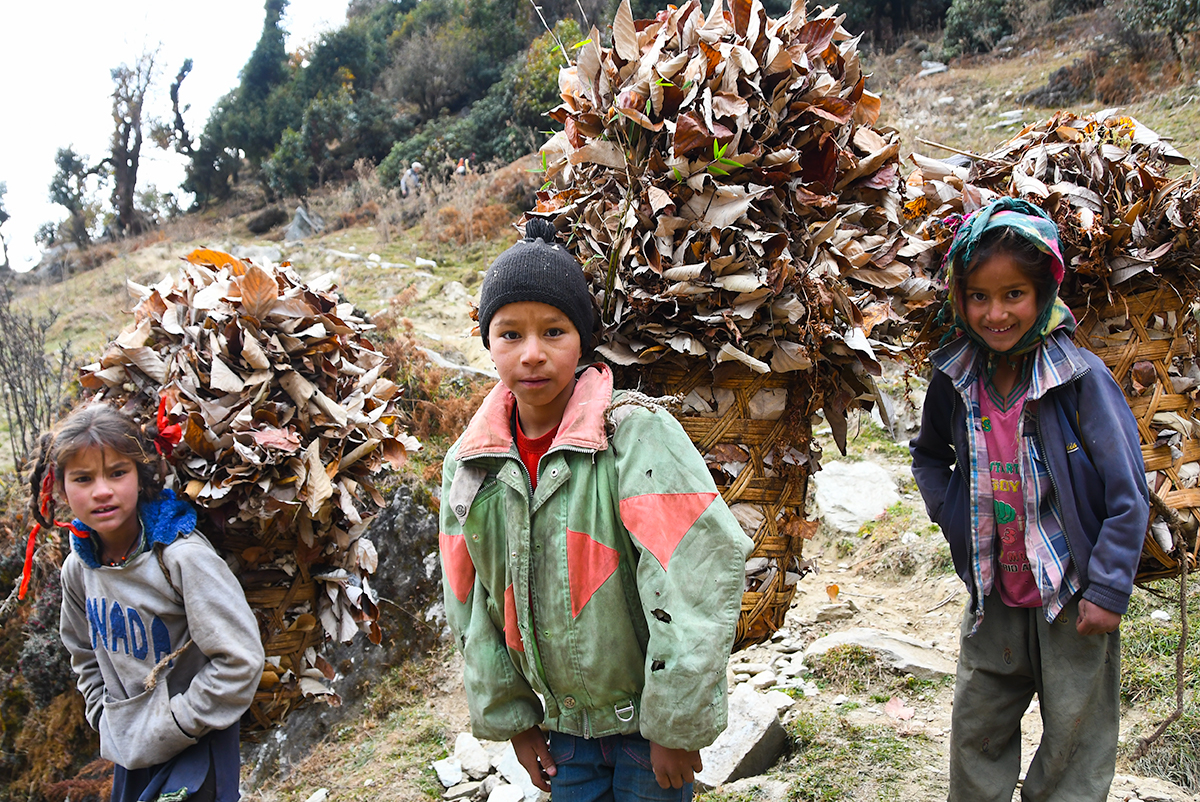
xmin=439 ymin=219 xmax=752 ymax=802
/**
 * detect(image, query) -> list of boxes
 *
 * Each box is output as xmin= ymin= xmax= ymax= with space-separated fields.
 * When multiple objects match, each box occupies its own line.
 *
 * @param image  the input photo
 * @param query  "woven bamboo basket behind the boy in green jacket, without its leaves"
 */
xmin=614 ymin=360 xmax=817 ymax=651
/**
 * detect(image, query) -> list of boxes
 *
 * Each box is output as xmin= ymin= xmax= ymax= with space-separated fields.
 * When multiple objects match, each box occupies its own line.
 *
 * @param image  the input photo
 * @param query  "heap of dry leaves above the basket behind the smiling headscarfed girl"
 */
xmin=878 ymin=110 xmax=1200 ymax=328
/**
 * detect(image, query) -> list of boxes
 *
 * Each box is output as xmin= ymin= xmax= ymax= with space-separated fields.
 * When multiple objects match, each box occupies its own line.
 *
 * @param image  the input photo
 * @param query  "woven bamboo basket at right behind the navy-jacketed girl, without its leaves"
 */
xmin=1074 ymin=288 xmax=1200 ymax=583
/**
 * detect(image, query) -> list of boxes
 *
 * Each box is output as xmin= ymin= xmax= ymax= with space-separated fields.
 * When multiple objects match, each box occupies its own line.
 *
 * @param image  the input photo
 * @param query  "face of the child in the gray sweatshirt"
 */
xmin=62 ymin=448 xmax=142 ymax=546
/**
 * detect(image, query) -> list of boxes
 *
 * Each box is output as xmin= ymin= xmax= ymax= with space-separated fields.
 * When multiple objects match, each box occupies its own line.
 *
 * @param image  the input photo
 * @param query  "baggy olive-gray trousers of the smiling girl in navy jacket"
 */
xmin=948 ymin=592 xmax=1121 ymax=802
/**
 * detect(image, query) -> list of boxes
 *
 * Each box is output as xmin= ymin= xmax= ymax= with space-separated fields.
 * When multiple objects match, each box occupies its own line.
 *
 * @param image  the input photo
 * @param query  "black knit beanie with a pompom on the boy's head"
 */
xmin=479 ymin=217 xmax=593 ymax=355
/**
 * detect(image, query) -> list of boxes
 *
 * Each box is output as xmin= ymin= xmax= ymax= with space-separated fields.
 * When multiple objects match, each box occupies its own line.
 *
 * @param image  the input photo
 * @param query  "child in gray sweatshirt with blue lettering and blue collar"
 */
xmin=32 ymin=405 xmax=263 ymax=802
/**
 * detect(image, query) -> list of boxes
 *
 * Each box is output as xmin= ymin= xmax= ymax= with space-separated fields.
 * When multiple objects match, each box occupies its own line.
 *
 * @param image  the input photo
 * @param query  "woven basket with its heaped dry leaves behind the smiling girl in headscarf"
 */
xmin=864 ymin=110 xmax=1200 ymax=569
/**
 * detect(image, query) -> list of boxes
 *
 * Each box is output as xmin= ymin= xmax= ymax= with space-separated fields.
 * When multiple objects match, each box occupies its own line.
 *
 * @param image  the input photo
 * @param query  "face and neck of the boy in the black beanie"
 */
xmin=487 ymin=301 xmax=583 ymax=437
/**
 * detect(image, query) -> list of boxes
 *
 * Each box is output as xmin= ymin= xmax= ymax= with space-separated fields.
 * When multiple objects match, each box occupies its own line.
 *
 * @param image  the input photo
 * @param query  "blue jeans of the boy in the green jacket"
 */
xmin=550 ymin=732 xmax=691 ymax=802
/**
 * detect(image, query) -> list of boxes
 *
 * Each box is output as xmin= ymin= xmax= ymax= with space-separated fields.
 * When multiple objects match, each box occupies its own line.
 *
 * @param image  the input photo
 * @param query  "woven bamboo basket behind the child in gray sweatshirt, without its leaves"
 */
xmin=210 ymin=533 xmax=323 ymax=732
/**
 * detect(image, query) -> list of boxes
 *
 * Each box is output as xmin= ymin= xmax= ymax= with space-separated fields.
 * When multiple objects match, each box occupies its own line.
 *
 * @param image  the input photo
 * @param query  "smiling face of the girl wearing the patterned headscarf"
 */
xmin=962 ymin=253 xmax=1038 ymax=353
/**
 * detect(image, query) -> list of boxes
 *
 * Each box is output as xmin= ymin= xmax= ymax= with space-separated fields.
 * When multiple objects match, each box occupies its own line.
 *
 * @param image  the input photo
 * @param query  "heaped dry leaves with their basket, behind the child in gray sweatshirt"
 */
xmin=80 ymin=250 xmax=420 ymax=725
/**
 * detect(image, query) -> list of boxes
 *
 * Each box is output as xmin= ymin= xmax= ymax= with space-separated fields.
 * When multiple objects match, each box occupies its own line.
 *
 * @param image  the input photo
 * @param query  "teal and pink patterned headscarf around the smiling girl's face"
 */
xmin=943 ymin=197 xmax=1075 ymax=357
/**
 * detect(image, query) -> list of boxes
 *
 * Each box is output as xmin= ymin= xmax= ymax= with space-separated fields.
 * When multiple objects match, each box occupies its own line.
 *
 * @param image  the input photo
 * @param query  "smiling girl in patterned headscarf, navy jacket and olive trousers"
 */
xmin=910 ymin=198 xmax=1150 ymax=802
